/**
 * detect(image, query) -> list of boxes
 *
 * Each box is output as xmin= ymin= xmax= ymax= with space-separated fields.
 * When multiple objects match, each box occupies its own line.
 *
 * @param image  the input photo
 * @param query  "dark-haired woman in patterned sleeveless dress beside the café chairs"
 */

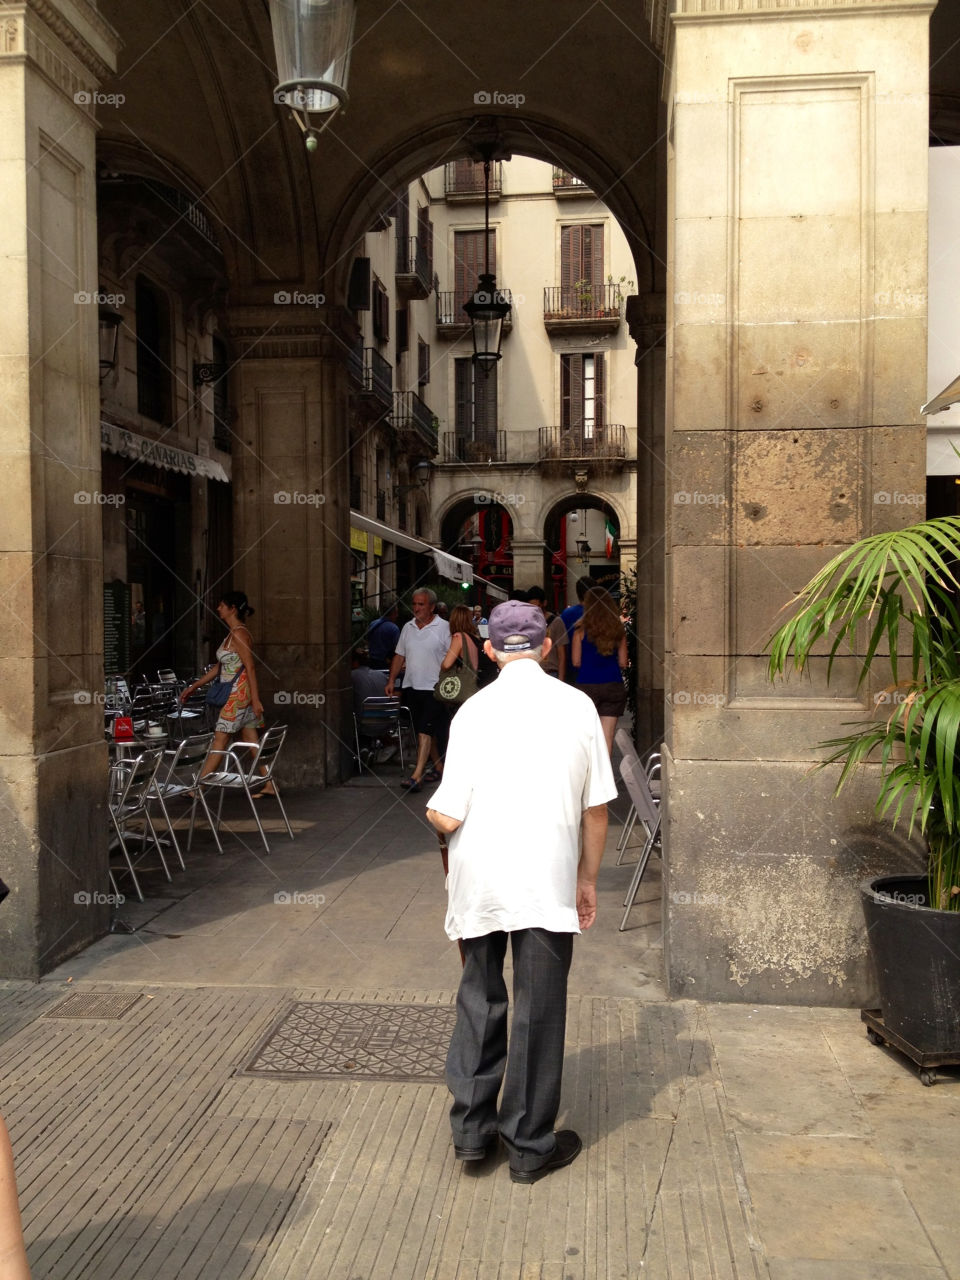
xmin=180 ymin=591 xmax=275 ymax=796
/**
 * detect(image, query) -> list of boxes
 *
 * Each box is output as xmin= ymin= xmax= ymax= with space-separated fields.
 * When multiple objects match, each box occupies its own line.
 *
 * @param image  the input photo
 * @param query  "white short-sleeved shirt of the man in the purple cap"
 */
xmin=430 ymin=658 xmax=617 ymax=938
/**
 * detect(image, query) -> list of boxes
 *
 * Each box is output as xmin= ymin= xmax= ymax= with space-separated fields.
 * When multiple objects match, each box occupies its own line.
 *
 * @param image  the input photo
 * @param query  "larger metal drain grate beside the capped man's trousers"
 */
xmin=239 ymin=1001 xmax=457 ymax=1084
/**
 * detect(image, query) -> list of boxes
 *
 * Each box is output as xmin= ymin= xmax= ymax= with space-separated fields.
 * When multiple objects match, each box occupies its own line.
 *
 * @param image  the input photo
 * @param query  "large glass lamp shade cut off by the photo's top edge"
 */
xmin=270 ymin=0 xmax=356 ymax=114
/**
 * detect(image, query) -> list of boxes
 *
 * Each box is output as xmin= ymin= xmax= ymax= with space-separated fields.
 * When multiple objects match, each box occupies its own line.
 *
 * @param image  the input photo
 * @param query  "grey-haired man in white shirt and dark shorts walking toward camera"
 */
xmin=384 ymin=586 xmax=451 ymax=791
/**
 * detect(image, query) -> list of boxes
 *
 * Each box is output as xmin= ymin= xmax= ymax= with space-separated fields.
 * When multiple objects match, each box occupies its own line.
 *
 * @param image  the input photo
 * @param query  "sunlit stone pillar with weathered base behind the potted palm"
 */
xmin=664 ymin=0 xmax=933 ymax=1005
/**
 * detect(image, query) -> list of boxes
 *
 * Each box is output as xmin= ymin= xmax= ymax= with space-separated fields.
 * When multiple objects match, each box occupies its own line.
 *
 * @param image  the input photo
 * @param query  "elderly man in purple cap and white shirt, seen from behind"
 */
xmin=426 ymin=600 xmax=617 ymax=1183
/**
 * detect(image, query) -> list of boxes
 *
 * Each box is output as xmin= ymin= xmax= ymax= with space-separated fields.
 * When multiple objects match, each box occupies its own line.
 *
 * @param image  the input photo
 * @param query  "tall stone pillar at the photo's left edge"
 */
xmin=0 ymin=0 xmax=118 ymax=979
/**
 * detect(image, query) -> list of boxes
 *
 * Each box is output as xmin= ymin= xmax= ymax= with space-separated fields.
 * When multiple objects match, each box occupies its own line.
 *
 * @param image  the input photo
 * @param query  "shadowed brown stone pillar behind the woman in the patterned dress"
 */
xmin=230 ymin=303 xmax=352 ymax=785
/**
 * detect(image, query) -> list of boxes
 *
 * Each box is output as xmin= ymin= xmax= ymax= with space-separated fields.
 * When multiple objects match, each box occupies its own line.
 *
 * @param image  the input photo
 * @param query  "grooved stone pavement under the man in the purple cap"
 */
xmin=0 ymin=786 xmax=960 ymax=1280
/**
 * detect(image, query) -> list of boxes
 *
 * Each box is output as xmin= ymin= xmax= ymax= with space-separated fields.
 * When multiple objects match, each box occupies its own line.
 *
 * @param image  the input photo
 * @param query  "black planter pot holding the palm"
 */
xmin=860 ymin=876 xmax=960 ymax=1055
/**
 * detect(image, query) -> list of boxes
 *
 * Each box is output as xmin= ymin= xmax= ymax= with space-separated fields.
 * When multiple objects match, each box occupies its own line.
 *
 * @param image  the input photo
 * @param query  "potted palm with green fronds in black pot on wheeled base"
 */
xmin=769 ymin=517 xmax=960 ymax=1083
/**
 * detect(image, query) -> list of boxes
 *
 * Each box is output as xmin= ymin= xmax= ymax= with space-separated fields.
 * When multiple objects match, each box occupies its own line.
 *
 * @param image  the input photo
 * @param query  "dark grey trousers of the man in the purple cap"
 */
xmin=447 ymin=929 xmax=573 ymax=1170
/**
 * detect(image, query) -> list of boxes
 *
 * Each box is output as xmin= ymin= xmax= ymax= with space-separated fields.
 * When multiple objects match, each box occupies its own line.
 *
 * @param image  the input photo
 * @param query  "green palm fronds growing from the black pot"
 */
xmin=769 ymin=516 xmax=960 ymax=910
